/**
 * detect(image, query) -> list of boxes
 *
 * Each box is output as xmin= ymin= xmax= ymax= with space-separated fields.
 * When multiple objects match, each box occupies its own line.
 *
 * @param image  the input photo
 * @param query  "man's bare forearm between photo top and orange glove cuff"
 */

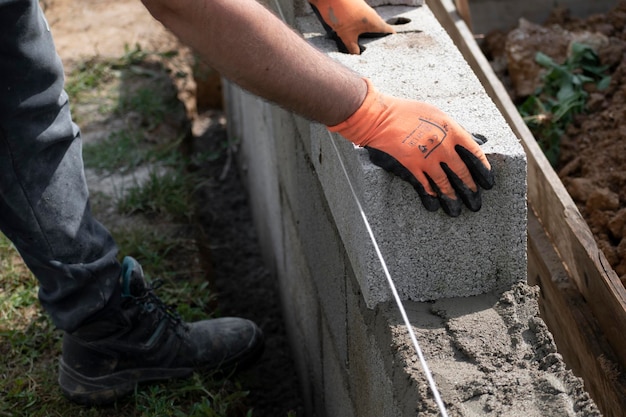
xmin=142 ymin=0 xmax=367 ymax=125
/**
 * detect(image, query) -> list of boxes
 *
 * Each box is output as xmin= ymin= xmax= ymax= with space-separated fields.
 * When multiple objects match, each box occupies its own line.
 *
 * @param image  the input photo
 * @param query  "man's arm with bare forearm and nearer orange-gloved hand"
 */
xmin=142 ymin=0 xmax=494 ymax=216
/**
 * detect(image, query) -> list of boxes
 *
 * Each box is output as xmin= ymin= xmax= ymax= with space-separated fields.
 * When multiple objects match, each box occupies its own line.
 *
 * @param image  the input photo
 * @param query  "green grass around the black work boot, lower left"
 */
xmin=0 ymin=228 xmax=247 ymax=417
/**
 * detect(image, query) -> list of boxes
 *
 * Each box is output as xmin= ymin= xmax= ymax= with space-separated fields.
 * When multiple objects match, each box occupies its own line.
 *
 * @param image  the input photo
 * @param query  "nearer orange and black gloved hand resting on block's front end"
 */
xmin=328 ymin=79 xmax=494 ymax=217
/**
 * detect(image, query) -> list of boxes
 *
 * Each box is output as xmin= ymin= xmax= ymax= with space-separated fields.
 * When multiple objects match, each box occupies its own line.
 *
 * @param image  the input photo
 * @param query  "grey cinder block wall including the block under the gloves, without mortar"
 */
xmin=225 ymin=1 xmax=526 ymax=417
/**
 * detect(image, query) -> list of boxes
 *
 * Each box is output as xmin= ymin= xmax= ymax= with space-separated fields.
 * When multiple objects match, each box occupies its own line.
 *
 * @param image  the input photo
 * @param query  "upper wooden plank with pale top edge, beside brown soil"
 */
xmin=426 ymin=0 xmax=626 ymax=369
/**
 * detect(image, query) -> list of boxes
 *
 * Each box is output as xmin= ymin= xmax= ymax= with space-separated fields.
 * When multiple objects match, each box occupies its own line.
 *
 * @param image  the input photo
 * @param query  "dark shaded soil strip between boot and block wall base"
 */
xmin=194 ymin=111 xmax=305 ymax=417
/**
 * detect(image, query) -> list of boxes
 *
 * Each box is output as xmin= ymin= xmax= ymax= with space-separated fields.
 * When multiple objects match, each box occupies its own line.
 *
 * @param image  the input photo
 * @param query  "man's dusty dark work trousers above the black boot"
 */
xmin=0 ymin=0 xmax=121 ymax=331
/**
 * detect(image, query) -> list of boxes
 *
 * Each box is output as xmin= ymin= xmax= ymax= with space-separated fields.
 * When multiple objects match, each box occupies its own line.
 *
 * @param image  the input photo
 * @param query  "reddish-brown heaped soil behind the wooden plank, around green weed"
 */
xmin=483 ymin=1 xmax=626 ymax=285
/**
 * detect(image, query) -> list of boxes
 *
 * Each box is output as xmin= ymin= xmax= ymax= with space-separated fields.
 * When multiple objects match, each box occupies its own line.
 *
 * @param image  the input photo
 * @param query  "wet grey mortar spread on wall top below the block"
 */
xmin=387 ymin=284 xmax=601 ymax=417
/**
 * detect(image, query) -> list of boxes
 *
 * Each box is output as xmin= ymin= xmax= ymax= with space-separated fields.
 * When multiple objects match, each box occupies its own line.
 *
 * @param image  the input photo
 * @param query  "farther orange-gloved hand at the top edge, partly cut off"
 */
xmin=309 ymin=0 xmax=395 ymax=55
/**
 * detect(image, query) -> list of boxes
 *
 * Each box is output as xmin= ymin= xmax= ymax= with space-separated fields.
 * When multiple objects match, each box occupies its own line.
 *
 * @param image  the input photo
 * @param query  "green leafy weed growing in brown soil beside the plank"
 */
xmin=518 ymin=43 xmax=611 ymax=166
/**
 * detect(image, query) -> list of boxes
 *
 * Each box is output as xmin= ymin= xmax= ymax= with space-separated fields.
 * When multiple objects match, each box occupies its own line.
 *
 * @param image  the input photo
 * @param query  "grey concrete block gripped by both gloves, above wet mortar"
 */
xmin=298 ymin=6 xmax=526 ymax=307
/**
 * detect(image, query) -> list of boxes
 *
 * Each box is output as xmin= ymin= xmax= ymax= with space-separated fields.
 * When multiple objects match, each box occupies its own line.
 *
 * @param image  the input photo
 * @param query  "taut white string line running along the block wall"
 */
xmin=327 ymin=131 xmax=448 ymax=417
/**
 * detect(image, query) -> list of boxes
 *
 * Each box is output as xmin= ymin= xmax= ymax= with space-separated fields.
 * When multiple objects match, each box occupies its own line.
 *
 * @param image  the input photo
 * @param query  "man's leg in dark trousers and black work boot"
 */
xmin=0 ymin=0 xmax=263 ymax=405
